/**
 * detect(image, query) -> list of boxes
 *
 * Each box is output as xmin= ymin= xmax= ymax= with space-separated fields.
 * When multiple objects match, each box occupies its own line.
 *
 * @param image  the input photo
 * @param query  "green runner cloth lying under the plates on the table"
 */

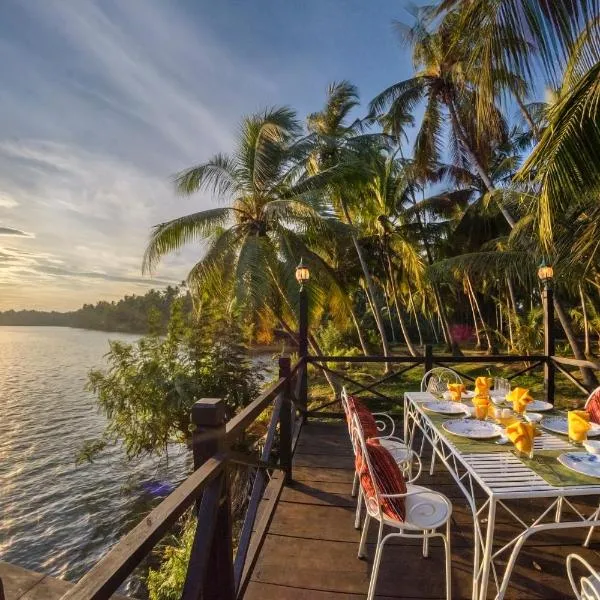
xmin=423 ymin=409 xmax=600 ymax=487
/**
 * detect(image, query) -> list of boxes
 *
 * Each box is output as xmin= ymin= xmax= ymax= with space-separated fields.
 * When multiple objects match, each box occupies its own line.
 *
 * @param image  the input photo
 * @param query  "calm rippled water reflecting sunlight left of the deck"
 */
xmin=0 ymin=327 xmax=204 ymax=580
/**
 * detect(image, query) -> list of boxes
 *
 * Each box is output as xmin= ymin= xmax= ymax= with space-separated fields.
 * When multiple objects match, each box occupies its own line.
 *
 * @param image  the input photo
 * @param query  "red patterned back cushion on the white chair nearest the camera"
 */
xmin=356 ymin=440 xmax=406 ymax=522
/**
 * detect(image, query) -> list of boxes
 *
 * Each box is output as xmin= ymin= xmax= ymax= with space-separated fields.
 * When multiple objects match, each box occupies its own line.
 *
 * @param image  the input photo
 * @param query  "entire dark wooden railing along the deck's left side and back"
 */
xmin=52 ymin=346 xmax=600 ymax=600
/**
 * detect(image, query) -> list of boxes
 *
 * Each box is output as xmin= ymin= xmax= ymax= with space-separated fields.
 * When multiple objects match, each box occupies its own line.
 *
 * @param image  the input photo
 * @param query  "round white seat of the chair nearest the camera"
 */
xmin=384 ymin=484 xmax=452 ymax=531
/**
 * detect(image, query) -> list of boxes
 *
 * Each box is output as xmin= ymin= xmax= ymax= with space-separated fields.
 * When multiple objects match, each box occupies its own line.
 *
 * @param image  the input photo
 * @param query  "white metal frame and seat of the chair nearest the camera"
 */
xmin=352 ymin=415 xmax=452 ymax=600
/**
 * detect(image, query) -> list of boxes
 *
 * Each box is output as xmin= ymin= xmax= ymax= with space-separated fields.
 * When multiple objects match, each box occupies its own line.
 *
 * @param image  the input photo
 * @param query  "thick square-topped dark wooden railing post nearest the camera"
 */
xmin=188 ymin=398 xmax=235 ymax=600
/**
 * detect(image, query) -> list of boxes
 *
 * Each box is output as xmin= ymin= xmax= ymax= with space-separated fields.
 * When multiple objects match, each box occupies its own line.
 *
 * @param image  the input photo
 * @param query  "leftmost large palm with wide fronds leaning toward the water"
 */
xmin=143 ymin=108 xmax=335 ymax=352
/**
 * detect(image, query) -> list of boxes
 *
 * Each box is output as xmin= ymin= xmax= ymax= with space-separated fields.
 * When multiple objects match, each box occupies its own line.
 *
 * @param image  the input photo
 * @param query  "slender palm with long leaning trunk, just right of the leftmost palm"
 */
xmin=307 ymin=81 xmax=390 ymax=356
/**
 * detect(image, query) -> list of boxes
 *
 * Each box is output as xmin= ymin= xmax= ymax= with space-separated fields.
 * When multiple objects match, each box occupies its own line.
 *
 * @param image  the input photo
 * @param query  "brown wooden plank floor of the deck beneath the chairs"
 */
xmin=244 ymin=422 xmax=600 ymax=600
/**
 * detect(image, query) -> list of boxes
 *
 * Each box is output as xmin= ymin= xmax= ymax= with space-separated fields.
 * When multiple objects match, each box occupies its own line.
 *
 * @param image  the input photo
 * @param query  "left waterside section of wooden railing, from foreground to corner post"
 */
xmin=62 ymin=358 xmax=306 ymax=600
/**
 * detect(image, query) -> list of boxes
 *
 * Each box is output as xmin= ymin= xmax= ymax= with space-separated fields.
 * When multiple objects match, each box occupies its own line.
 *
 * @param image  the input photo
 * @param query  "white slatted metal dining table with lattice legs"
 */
xmin=404 ymin=392 xmax=600 ymax=600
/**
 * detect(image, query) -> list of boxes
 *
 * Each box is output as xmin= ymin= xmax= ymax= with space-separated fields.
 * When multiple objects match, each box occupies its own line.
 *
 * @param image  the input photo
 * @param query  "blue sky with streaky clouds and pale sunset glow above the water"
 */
xmin=0 ymin=0 xmax=418 ymax=310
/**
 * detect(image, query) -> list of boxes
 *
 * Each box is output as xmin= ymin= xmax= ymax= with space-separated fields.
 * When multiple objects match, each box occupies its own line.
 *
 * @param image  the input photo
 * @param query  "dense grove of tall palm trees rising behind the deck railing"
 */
xmin=144 ymin=0 xmax=600 ymax=385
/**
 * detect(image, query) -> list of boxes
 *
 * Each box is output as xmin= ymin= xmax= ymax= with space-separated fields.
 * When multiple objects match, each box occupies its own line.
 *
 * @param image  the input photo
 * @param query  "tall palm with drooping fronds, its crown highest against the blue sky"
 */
xmin=370 ymin=13 xmax=517 ymax=226
